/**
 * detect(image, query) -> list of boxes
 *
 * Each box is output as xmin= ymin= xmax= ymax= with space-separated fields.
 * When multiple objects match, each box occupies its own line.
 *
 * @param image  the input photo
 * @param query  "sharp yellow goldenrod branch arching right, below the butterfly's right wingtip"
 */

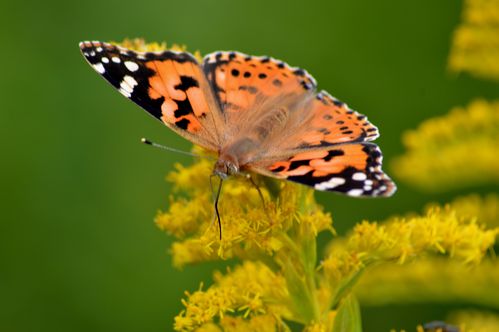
xmin=321 ymin=207 xmax=499 ymax=312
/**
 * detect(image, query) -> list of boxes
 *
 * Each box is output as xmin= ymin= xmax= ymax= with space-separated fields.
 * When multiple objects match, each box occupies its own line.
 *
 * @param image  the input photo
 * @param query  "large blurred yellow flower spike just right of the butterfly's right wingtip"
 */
xmin=392 ymin=100 xmax=499 ymax=191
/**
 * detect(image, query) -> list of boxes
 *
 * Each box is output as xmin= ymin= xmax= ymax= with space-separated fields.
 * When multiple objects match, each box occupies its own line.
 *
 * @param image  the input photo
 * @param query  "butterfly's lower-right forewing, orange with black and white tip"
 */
xmin=262 ymin=143 xmax=396 ymax=196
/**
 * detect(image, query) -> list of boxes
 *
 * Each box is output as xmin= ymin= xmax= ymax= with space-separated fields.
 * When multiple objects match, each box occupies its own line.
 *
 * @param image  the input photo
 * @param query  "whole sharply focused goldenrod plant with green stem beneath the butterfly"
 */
xmin=160 ymin=159 xmax=499 ymax=331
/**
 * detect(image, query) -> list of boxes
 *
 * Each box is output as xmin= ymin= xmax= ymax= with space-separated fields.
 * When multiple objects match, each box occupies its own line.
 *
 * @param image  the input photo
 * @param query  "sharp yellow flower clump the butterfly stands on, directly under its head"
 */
xmin=156 ymin=154 xmax=332 ymax=267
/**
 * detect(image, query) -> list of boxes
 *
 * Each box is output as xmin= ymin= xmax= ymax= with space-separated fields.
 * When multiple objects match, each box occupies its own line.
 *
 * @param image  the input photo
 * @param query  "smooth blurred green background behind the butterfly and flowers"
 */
xmin=0 ymin=0 xmax=499 ymax=332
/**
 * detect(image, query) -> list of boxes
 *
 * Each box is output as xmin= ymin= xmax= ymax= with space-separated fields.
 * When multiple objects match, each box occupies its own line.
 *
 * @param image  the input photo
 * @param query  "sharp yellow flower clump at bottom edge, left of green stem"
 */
xmin=175 ymin=261 xmax=290 ymax=331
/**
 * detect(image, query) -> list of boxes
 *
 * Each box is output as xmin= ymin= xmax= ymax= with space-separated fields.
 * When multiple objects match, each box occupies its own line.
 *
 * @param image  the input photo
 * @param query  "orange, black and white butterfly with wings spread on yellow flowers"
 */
xmin=80 ymin=42 xmax=396 ymax=196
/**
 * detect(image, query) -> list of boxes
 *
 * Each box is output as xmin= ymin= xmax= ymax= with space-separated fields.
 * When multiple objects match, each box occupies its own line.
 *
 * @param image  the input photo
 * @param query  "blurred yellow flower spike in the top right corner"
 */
xmin=449 ymin=0 xmax=499 ymax=80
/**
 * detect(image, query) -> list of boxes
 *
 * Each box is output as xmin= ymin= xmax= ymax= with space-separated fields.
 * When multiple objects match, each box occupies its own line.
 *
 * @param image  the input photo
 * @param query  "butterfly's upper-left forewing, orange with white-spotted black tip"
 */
xmin=80 ymin=42 xmax=221 ymax=149
